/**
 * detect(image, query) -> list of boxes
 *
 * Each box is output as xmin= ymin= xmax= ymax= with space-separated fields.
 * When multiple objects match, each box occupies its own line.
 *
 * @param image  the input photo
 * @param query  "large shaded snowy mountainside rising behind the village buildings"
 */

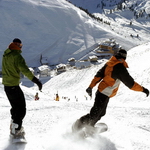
xmin=0 ymin=0 xmax=149 ymax=68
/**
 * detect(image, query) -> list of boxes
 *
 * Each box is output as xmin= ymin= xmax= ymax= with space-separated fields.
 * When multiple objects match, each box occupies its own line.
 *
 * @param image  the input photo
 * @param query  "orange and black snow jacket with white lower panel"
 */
xmin=89 ymin=56 xmax=143 ymax=97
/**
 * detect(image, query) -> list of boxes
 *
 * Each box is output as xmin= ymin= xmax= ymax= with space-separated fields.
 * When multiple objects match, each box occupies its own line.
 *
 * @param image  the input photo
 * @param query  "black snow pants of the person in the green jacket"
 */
xmin=4 ymin=86 xmax=26 ymax=130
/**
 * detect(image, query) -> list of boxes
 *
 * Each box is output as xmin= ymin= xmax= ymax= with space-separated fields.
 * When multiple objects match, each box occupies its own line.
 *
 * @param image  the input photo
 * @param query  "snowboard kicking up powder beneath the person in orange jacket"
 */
xmin=73 ymin=123 xmax=108 ymax=138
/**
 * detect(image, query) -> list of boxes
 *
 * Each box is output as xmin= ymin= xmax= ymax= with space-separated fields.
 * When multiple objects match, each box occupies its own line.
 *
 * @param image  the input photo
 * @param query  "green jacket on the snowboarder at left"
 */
xmin=2 ymin=49 xmax=34 ymax=86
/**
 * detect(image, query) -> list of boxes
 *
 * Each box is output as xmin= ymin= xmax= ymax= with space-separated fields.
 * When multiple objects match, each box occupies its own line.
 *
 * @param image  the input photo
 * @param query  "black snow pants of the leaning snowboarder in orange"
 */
xmin=80 ymin=90 xmax=109 ymax=126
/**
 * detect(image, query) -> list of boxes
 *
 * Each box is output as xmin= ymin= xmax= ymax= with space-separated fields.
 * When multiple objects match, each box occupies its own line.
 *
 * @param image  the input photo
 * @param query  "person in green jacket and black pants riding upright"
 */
xmin=2 ymin=38 xmax=42 ymax=136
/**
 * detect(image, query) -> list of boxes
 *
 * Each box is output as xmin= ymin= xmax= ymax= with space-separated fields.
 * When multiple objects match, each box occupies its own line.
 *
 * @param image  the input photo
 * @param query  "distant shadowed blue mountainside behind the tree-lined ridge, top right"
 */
xmin=69 ymin=0 xmax=150 ymax=15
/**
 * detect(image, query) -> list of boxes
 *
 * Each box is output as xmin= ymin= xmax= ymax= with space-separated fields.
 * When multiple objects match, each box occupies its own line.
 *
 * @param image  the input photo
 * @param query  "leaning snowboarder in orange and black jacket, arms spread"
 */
xmin=72 ymin=49 xmax=149 ymax=131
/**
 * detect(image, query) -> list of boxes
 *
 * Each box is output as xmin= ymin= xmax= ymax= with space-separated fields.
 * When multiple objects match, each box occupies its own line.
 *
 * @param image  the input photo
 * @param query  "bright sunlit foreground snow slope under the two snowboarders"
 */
xmin=0 ymin=43 xmax=150 ymax=150
